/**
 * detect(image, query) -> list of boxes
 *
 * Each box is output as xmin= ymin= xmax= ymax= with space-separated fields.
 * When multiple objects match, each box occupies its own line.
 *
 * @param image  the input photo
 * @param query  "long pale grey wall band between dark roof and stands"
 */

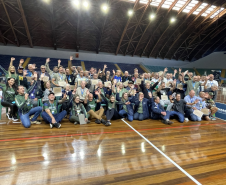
xmin=0 ymin=45 xmax=189 ymax=67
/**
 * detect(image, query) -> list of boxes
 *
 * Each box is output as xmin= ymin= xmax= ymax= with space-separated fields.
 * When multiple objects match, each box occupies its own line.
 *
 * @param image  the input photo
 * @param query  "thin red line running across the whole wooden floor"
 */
xmin=0 ymin=123 xmax=226 ymax=142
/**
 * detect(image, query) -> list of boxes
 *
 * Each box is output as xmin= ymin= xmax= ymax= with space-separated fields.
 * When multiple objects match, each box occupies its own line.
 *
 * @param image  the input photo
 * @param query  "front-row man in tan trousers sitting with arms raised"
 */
xmin=84 ymin=90 xmax=106 ymax=125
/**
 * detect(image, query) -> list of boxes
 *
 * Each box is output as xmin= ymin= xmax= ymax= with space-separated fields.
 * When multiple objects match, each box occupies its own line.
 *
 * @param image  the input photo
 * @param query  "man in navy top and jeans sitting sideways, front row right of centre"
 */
xmin=151 ymin=96 xmax=173 ymax=125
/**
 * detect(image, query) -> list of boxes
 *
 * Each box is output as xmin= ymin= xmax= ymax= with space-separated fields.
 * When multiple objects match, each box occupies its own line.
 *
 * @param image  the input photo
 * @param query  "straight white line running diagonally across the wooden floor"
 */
xmin=121 ymin=119 xmax=202 ymax=185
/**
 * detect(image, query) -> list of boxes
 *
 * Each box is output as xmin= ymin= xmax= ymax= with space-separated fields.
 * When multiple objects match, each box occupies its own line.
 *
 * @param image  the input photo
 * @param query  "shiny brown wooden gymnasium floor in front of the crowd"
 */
xmin=0 ymin=110 xmax=226 ymax=185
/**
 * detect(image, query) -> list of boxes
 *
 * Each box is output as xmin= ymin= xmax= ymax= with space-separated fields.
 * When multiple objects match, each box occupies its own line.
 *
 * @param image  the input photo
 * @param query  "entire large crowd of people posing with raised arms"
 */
xmin=0 ymin=56 xmax=218 ymax=128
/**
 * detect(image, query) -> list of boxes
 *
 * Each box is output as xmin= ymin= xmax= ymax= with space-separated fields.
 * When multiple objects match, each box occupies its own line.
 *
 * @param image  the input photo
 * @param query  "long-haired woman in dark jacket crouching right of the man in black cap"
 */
xmin=69 ymin=95 xmax=89 ymax=125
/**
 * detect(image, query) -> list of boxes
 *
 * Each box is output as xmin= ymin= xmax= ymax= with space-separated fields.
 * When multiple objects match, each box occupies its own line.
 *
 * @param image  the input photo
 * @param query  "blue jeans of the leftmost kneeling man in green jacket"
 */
xmin=19 ymin=107 xmax=42 ymax=128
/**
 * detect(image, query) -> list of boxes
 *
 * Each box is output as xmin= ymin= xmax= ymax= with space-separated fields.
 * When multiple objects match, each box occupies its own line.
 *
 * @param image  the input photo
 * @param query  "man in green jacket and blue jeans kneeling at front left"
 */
xmin=15 ymin=86 xmax=42 ymax=128
